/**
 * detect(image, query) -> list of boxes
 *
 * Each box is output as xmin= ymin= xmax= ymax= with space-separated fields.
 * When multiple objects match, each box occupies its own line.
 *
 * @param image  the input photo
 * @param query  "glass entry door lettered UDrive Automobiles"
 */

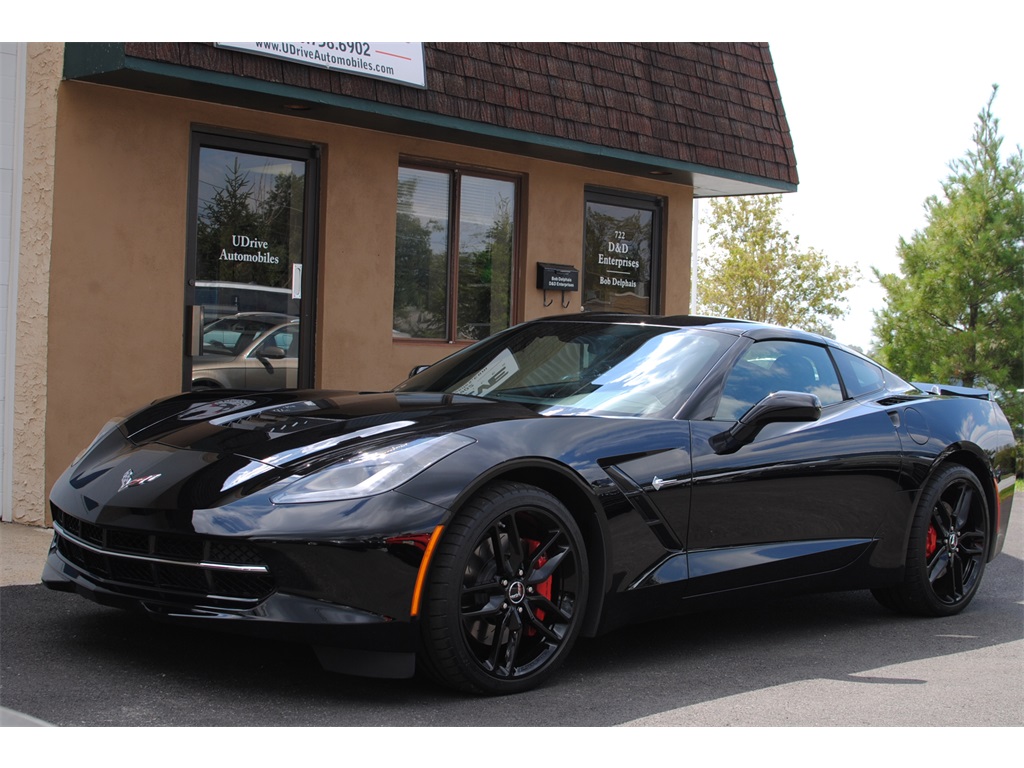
xmin=183 ymin=133 xmax=316 ymax=390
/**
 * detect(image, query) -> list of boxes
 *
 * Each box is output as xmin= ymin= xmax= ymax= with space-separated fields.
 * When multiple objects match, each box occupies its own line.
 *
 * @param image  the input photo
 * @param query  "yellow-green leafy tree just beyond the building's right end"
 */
xmin=697 ymin=195 xmax=857 ymax=336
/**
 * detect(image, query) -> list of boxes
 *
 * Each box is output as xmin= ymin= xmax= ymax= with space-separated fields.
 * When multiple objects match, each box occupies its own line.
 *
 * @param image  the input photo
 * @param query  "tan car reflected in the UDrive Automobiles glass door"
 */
xmin=191 ymin=312 xmax=299 ymax=391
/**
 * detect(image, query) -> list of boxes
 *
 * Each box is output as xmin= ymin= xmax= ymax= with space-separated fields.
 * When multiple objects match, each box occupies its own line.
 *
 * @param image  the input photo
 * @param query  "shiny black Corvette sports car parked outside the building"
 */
xmin=43 ymin=314 xmax=1015 ymax=693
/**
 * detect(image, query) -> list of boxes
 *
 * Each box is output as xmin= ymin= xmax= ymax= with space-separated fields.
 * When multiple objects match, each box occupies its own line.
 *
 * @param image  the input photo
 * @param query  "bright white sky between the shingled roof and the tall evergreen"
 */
xmin=768 ymin=30 xmax=1024 ymax=351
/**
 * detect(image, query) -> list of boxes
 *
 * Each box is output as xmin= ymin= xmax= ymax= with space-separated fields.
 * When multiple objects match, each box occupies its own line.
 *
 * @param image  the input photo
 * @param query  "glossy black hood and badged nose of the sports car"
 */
xmin=50 ymin=390 xmax=541 ymax=518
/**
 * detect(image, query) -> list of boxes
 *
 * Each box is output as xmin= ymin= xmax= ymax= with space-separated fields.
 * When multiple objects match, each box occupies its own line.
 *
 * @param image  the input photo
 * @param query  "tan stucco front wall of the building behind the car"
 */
xmin=39 ymin=82 xmax=692 ymax=518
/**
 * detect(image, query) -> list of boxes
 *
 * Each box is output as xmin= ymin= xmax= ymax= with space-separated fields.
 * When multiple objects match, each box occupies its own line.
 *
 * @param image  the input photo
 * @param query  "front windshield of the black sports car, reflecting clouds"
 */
xmin=395 ymin=322 xmax=734 ymax=418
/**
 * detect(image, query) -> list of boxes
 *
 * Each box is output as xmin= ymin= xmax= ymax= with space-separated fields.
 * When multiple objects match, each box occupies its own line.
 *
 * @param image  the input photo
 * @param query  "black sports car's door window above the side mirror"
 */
xmin=715 ymin=341 xmax=843 ymax=421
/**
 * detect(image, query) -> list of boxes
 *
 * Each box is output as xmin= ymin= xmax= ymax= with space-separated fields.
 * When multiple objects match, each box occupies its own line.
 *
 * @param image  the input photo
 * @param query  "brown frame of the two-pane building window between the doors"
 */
xmin=391 ymin=157 xmax=525 ymax=345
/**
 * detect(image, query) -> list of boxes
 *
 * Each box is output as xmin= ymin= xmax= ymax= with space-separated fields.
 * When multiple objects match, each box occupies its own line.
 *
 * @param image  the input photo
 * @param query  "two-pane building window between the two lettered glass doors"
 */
xmin=393 ymin=166 xmax=518 ymax=341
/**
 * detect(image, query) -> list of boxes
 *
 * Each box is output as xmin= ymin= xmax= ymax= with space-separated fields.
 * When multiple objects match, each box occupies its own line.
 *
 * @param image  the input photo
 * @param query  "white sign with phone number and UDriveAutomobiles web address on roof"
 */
xmin=216 ymin=42 xmax=427 ymax=88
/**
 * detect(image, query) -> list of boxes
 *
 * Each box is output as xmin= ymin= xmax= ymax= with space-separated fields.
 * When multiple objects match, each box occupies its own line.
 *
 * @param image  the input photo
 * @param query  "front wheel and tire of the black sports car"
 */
xmin=420 ymin=482 xmax=589 ymax=695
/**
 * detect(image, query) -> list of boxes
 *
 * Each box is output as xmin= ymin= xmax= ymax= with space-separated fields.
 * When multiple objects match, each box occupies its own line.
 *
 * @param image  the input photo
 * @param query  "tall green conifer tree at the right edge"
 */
xmin=874 ymin=86 xmax=1024 ymax=403
